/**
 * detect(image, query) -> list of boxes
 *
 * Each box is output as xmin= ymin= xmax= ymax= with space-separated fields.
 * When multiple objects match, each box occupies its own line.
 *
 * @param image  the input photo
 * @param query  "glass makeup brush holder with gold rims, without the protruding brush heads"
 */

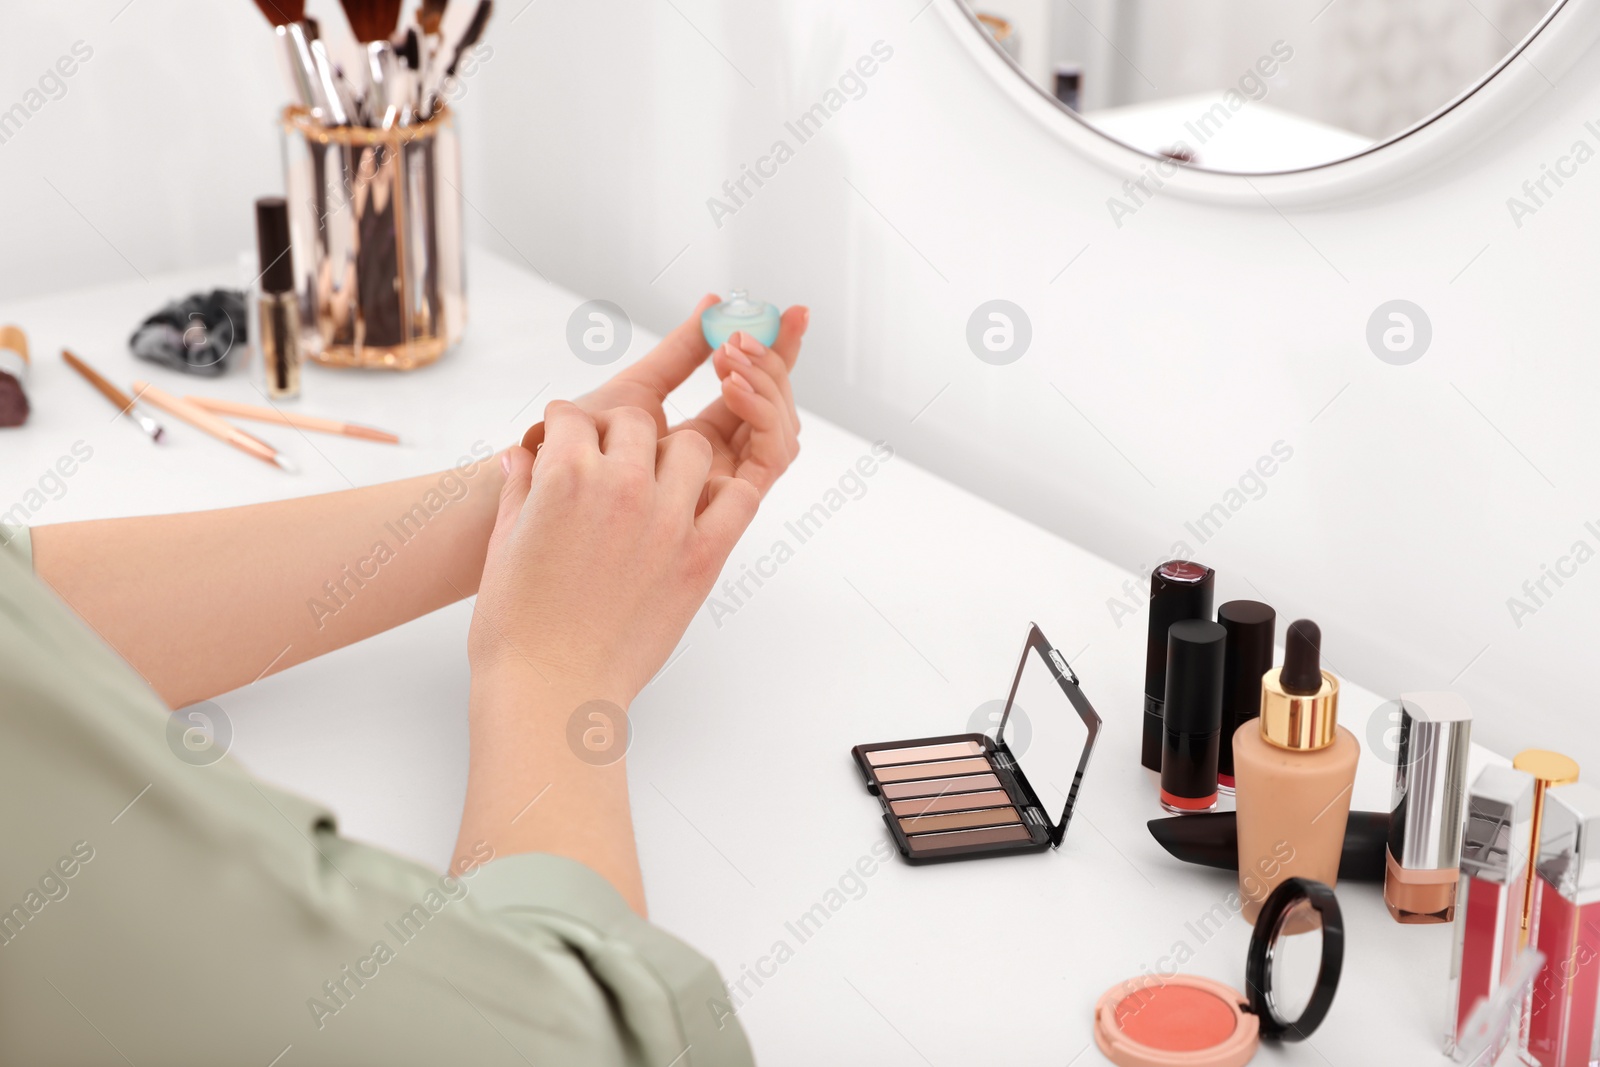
xmin=283 ymin=107 xmax=467 ymax=371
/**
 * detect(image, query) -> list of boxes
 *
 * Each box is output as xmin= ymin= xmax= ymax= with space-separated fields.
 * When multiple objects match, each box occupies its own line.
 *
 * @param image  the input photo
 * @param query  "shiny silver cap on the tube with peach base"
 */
xmin=1389 ymin=693 xmax=1472 ymax=870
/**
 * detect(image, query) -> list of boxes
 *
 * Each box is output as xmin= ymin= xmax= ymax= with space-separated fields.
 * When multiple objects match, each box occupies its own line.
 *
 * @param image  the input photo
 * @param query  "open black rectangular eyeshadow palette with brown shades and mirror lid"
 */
xmin=850 ymin=625 xmax=1101 ymax=864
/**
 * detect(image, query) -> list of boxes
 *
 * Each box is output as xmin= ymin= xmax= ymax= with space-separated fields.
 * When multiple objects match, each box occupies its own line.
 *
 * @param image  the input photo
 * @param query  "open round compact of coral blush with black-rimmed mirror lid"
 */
xmin=1094 ymin=878 xmax=1344 ymax=1067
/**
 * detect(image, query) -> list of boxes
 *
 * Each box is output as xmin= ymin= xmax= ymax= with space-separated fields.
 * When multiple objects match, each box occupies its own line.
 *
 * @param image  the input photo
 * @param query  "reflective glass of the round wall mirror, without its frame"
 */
xmin=962 ymin=0 xmax=1562 ymax=174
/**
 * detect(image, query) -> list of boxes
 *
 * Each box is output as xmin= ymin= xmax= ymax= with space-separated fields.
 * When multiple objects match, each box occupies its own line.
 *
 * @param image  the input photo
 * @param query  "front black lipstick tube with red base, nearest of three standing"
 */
xmin=1162 ymin=619 xmax=1227 ymax=816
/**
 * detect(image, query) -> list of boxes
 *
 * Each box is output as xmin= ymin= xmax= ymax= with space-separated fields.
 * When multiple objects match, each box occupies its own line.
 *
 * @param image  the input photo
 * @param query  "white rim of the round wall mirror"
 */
xmin=930 ymin=0 xmax=1600 ymax=206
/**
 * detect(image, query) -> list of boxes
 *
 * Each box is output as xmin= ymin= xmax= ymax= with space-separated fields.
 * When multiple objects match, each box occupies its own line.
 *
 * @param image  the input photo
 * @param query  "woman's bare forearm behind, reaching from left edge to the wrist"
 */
xmin=34 ymin=443 xmax=504 ymax=707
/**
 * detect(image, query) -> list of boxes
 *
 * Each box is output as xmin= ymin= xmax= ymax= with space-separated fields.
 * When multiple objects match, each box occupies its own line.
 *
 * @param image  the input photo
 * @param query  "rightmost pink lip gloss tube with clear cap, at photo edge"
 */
xmin=1523 ymin=782 xmax=1600 ymax=1067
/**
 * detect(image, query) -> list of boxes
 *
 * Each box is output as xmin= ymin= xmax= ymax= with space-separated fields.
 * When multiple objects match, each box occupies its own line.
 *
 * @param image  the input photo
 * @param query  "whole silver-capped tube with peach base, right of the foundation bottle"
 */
xmin=1384 ymin=693 xmax=1472 ymax=923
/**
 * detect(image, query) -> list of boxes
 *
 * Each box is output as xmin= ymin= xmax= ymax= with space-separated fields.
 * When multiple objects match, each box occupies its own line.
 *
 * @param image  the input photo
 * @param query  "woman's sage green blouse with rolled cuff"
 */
xmin=0 ymin=528 xmax=752 ymax=1067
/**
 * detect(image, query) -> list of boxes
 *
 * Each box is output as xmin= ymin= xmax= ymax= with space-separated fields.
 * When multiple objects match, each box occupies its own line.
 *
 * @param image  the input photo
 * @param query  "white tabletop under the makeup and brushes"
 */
xmin=0 ymin=253 xmax=1496 ymax=1067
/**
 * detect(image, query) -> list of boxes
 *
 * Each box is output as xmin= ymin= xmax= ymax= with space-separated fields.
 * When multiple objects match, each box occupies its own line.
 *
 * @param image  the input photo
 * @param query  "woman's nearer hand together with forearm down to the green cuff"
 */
xmin=451 ymin=402 xmax=760 ymax=915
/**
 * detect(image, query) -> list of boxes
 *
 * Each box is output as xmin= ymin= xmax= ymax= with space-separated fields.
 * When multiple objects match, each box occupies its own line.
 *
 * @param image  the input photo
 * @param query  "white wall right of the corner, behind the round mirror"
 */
xmin=469 ymin=0 xmax=1600 ymax=765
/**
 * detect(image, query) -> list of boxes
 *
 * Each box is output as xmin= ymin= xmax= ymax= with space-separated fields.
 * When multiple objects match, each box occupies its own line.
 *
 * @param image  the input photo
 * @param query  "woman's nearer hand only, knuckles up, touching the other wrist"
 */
xmin=469 ymin=402 xmax=760 ymax=707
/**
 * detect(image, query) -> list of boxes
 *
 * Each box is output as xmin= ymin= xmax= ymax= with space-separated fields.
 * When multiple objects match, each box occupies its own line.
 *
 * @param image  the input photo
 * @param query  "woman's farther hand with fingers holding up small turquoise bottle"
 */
xmin=523 ymin=294 xmax=811 ymax=496
